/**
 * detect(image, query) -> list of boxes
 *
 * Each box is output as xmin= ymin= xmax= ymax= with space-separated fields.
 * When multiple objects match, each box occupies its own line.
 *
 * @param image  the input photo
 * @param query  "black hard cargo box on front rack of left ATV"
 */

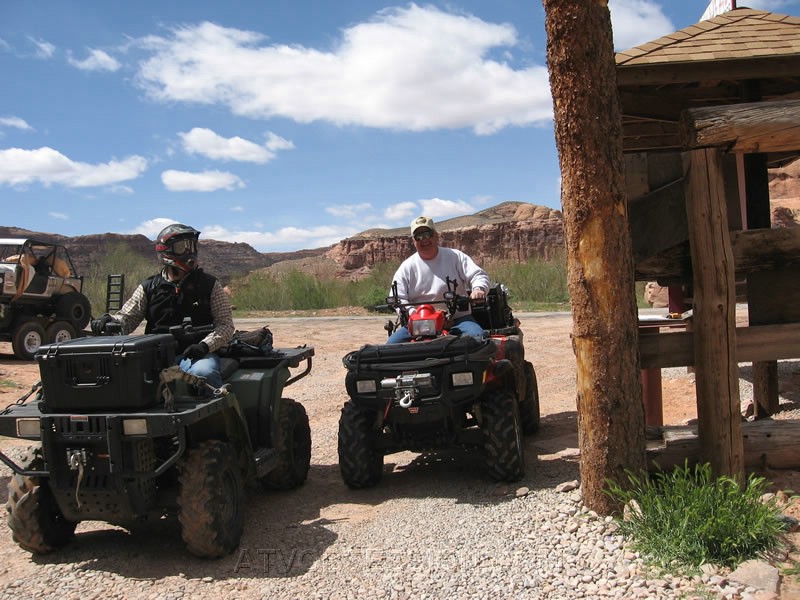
xmin=36 ymin=334 xmax=176 ymax=412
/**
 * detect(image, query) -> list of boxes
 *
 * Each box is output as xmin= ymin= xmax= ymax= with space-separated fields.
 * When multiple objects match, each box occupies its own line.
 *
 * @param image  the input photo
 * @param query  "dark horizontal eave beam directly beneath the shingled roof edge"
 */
xmin=617 ymin=56 xmax=800 ymax=87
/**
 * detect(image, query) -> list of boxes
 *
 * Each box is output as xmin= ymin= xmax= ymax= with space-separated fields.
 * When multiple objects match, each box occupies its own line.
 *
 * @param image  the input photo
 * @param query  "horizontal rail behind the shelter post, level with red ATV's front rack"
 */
xmin=639 ymin=323 xmax=800 ymax=369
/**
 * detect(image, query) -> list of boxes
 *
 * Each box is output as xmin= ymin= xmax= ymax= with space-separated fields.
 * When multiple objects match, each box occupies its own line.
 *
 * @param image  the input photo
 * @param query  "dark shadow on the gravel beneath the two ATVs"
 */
xmin=12 ymin=413 xmax=578 ymax=581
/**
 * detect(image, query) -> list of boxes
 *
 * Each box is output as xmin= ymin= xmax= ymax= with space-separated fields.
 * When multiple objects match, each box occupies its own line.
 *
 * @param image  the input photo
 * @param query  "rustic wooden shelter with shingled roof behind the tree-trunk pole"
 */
xmin=616 ymin=8 xmax=800 ymax=473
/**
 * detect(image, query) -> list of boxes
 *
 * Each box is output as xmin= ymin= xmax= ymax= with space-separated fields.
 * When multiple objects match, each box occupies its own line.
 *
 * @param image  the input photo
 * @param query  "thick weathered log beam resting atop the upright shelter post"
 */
xmin=680 ymin=100 xmax=800 ymax=153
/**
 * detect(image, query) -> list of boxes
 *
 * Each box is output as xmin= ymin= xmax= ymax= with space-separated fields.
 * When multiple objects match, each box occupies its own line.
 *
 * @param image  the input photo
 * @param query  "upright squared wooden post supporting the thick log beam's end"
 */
xmin=684 ymin=149 xmax=744 ymax=476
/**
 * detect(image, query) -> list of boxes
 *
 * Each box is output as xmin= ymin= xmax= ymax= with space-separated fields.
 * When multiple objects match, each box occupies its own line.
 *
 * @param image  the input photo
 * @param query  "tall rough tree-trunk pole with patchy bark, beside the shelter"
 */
xmin=543 ymin=0 xmax=645 ymax=514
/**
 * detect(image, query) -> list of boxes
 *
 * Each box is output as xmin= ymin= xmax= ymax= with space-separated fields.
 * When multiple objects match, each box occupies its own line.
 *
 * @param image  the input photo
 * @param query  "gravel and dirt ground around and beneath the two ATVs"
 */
xmin=0 ymin=314 xmax=796 ymax=600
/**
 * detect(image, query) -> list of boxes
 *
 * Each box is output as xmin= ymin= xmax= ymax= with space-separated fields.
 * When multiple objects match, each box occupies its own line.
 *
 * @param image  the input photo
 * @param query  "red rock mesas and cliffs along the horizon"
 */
xmin=0 ymin=169 xmax=800 ymax=284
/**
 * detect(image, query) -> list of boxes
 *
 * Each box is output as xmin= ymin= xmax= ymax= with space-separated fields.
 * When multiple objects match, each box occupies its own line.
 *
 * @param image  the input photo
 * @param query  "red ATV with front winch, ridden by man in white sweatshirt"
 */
xmin=338 ymin=279 xmax=539 ymax=489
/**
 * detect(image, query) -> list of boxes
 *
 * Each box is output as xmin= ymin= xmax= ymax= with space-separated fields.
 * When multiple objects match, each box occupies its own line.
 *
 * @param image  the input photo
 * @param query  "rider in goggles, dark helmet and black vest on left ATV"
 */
xmin=92 ymin=223 xmax=234 ymax=388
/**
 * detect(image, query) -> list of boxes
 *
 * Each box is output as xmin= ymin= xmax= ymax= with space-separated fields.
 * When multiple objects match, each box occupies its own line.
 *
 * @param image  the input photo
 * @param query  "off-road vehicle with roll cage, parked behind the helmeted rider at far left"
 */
xmin=0 ymin=238 xmax=91 ymax=360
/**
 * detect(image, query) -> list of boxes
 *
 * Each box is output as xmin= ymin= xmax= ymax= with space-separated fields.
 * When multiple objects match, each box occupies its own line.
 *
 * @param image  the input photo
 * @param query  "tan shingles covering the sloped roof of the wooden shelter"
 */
xmin=616 ymin=8 xmax=800 ymax=66
